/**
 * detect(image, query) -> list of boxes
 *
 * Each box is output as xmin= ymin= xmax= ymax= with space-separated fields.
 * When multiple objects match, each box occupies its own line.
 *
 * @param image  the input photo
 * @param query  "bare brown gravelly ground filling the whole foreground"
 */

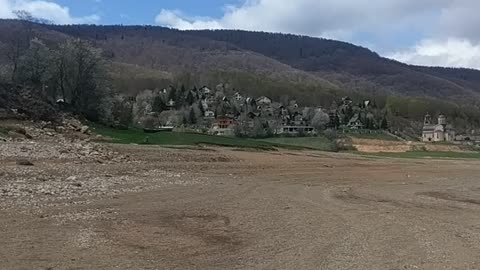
xmin=0 ymin=130 xmax=480 ymax=269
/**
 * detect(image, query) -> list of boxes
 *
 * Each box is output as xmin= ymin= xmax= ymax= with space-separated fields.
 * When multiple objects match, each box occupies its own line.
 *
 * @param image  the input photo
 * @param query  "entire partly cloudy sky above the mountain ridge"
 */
xmin=0 ymin=0 xmax=480 ymax=69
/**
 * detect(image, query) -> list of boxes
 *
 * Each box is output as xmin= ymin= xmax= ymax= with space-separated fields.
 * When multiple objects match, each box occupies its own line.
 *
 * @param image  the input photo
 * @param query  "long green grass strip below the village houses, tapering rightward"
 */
xmin=93 ymin=126 xmax=301 ymax=150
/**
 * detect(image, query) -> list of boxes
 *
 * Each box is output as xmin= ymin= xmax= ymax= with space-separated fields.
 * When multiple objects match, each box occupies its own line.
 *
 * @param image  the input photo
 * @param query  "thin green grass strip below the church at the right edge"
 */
xmin=358 ymin=151 xmax=480 ymax=159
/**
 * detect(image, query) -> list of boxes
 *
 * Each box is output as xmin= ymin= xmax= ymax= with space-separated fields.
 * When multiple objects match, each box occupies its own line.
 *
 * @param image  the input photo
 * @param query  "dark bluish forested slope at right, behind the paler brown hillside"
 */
xmin=188 ymin=30 xmax=480 ymax=99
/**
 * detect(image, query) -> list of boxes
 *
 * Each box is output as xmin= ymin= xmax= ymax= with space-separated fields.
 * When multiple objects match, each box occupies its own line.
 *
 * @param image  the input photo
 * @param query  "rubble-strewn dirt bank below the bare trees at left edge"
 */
xmin=0 ymin=118 xmax=132 ymax=163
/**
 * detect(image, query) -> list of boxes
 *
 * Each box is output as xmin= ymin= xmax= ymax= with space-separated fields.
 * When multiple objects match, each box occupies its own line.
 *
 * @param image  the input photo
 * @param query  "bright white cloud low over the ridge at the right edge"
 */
xmin=387 ymin=38 xmax=480 ymax=69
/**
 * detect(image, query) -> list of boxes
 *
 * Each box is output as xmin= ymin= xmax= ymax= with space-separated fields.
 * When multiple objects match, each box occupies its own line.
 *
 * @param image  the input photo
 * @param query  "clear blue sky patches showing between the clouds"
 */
xmin=42 ymin=0 xmax=420 ymax=53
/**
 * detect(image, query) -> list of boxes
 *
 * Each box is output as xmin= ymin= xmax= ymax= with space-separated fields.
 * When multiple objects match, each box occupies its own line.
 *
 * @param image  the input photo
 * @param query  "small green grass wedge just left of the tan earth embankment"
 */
xmin=258 ymin=137 xmax=336 ymax=151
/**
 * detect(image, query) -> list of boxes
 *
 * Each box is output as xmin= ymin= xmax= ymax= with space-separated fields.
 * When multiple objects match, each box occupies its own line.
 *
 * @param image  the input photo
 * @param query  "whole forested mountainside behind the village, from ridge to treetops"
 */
xmin=0 ymin=20 xmax=480 ymax=132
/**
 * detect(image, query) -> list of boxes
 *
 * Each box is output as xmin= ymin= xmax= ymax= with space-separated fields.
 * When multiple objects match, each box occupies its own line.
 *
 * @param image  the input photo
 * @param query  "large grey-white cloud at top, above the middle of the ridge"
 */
xmin=155 ymin=0 xmax=446 ymax=38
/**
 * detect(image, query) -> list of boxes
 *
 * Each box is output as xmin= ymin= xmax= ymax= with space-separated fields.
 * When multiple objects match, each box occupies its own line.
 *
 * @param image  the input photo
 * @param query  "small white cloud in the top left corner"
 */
xmin=0 ymin=0 xmax=100 ymax=24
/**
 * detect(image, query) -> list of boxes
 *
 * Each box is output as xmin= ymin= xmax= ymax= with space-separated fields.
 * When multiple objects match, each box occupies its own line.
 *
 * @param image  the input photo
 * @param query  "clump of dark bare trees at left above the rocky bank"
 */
xmin=2 ymin=33 xmax=113 ymax=121
